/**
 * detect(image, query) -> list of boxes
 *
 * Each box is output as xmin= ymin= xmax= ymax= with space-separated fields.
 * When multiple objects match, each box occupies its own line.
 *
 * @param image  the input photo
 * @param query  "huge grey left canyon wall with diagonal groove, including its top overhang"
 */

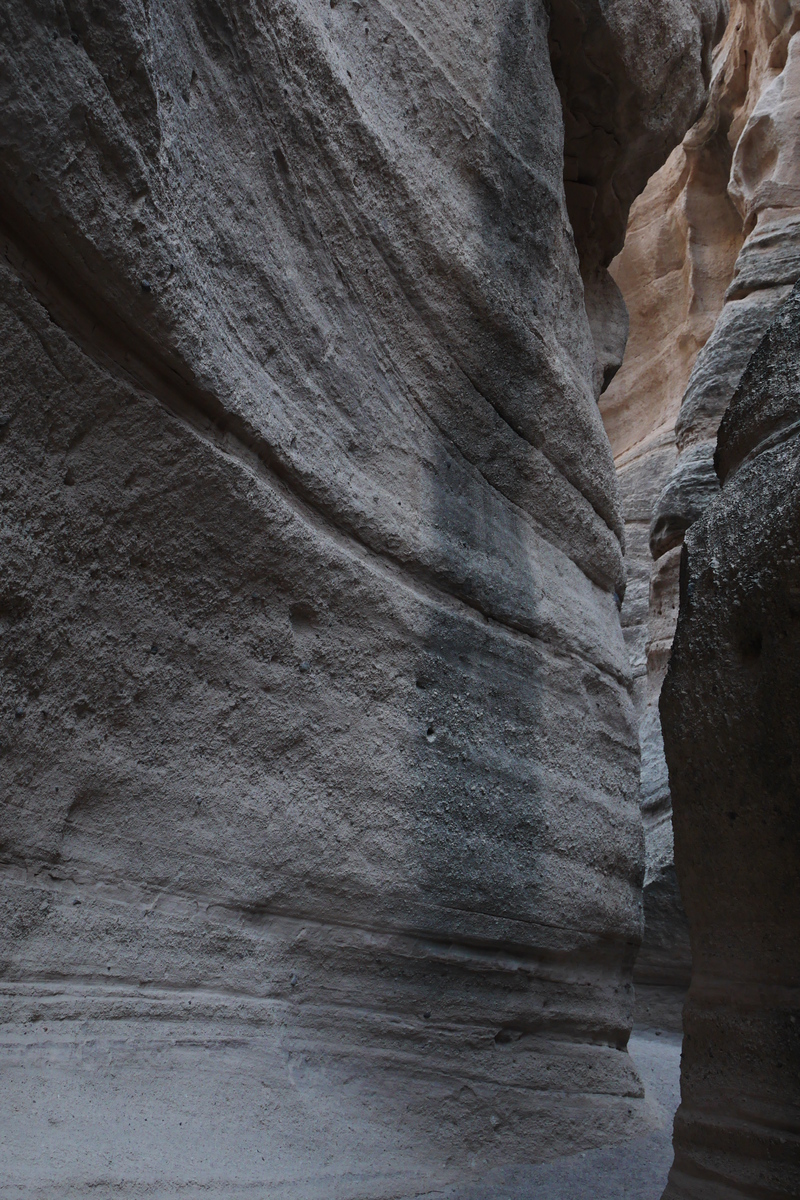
xmin=0 ymin=0 xmax=718 ymax=1198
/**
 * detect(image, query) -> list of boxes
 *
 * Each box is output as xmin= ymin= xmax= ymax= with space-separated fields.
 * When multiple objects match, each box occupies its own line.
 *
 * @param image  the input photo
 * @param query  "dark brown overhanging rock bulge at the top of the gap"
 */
xmin=549 ymin=0 xmax=726 ymax=394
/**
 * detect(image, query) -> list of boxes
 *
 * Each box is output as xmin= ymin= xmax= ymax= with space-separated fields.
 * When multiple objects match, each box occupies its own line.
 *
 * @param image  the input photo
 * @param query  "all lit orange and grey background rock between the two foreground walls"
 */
xmin=601 ymin=0 xmax=800 ymax=1012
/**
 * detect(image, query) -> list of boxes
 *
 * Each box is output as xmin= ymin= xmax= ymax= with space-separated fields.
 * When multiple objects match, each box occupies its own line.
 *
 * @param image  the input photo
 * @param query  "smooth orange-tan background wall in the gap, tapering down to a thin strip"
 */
xmin=601 ymin=88 xmax=741 ymax=1008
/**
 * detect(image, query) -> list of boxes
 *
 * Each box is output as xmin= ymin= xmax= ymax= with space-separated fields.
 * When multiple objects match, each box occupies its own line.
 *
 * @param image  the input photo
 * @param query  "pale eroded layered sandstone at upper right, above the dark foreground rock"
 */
xmin=652 ymin=2 xmax=800 ymax=554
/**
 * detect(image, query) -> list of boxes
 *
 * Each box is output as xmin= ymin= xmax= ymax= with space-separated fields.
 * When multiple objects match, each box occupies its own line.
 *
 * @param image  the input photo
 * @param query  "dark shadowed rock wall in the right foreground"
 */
xmin=661 ymin=289 xmax=800 ymax=1200
